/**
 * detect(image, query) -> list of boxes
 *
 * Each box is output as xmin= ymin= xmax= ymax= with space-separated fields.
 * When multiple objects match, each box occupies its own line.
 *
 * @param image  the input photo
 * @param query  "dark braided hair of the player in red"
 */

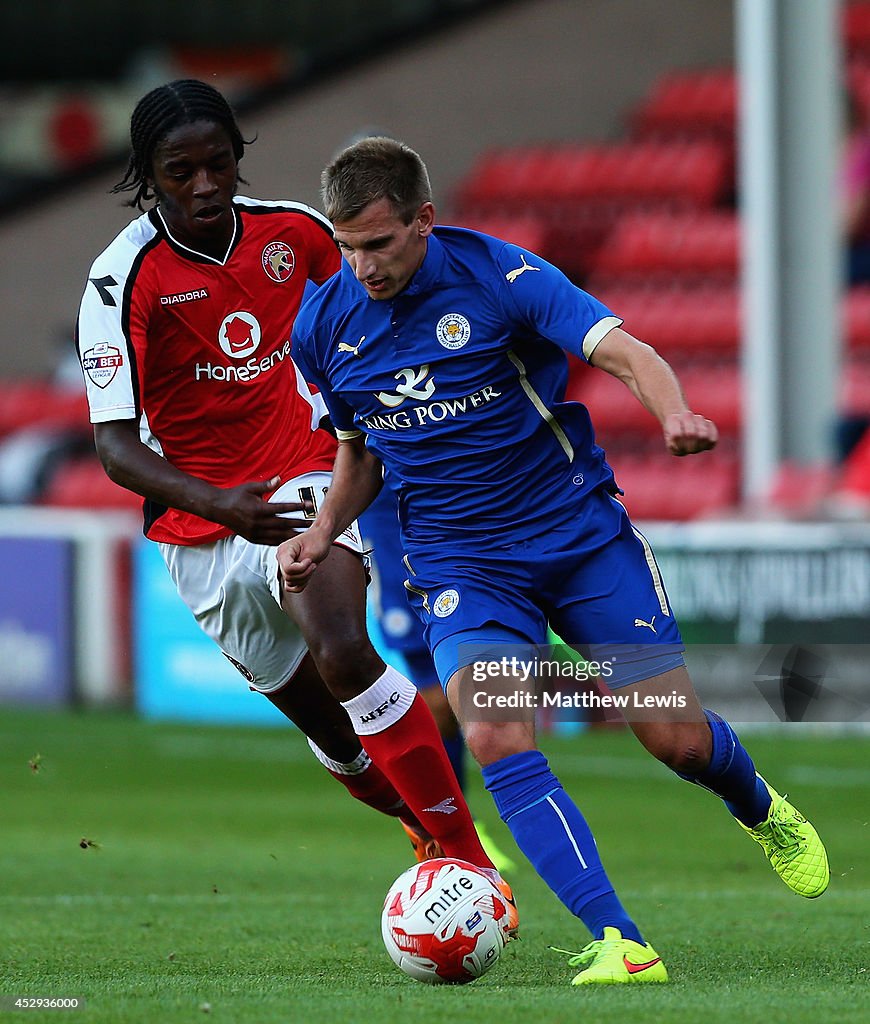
xmin=112 ymin=78 xmax=253 ymax=210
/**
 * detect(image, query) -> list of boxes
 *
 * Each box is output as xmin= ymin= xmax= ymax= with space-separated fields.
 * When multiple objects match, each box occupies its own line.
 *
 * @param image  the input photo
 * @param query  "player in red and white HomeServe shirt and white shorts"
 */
xmin=77 ymin=80 xmax=510 ymax=913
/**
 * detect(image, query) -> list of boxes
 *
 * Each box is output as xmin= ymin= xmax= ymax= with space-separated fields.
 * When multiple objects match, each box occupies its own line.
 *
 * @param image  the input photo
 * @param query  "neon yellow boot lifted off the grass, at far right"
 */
xmin=738 ymin=775 xmax=831 ymax=899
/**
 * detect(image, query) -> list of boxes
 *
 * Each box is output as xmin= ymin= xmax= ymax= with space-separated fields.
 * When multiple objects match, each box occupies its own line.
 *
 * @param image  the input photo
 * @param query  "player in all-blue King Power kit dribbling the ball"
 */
xmin=278 ymin=137 xmax=829 ymax=985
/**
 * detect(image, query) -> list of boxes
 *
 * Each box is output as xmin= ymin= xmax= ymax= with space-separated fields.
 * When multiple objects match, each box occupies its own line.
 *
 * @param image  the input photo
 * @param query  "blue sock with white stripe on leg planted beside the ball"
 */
xmin=483 ymin=751 xmax=644 ymax=943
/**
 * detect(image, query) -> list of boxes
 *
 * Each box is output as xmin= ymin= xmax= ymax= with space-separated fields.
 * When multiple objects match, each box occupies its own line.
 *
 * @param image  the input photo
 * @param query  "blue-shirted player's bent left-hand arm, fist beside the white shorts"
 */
xmin=277 ymin=434 xmax=384 ymax=594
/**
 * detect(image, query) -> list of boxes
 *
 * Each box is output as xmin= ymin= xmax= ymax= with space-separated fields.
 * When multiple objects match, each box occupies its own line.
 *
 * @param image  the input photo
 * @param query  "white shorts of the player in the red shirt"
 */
xmin=158 ymin=473 xmax=364 ymax=693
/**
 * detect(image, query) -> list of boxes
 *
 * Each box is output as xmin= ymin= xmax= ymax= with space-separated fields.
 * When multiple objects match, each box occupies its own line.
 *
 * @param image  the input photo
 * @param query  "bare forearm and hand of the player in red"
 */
xmin=94 ymin=420 xmax=308 ymax=545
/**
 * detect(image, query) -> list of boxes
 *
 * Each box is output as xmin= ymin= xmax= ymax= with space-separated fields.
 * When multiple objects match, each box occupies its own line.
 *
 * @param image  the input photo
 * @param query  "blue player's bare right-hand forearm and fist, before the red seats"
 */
xmin=590 ymin=328 xmax=719 ymax=456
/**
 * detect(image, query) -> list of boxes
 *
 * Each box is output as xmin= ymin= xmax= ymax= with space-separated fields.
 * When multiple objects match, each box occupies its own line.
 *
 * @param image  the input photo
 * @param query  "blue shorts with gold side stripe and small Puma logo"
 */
xmin=405 ymin=490 xmax=685 ymax=688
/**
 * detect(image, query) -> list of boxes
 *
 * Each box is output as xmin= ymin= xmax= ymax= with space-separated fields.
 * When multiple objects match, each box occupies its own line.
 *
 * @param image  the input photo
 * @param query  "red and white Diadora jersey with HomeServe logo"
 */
xmin=77 ymin=197 xmax=341 ymax=545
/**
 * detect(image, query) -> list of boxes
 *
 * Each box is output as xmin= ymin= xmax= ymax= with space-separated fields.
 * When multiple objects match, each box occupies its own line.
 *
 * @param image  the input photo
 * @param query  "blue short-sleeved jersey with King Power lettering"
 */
xmin=293 ymin=227 xmax=621 ymax=550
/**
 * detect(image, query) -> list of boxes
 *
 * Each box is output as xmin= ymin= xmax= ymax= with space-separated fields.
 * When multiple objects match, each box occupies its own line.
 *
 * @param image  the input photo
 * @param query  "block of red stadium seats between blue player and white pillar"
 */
xmin=453 ymin=57 xmax=740 ymax=520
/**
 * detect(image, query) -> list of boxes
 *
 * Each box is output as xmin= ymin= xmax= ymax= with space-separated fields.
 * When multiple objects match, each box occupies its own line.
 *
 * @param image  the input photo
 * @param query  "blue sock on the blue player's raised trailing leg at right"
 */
xmin=677 ymin=709 xmax=771 ymax=828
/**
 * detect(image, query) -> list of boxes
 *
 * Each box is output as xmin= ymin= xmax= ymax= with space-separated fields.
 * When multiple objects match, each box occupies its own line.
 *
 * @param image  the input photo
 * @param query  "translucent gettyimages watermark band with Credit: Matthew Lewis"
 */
xmin=450 ymin=644 xmax=870 ymax=723
